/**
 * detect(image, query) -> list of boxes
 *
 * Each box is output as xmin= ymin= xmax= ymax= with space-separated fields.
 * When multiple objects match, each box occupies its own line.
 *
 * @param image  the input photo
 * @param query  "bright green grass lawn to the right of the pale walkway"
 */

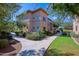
xmin=45 ymin=35 xmax=79 ymax=56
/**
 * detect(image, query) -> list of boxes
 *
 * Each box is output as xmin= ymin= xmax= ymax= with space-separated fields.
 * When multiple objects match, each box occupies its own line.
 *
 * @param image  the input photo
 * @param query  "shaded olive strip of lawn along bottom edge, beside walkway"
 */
xmin=44 ymin=49 xmax=74 ymax=56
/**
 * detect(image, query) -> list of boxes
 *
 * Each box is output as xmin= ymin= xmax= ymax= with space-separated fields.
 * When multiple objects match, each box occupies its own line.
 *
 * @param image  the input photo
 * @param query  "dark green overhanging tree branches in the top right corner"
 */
xmin=48 ymin=3 xmax=79 ymax=17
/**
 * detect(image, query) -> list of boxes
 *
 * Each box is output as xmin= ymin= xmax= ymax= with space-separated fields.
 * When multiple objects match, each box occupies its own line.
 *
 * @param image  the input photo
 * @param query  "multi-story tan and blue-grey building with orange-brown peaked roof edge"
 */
xmin=16 ymin=8 xmax=53 ymax=32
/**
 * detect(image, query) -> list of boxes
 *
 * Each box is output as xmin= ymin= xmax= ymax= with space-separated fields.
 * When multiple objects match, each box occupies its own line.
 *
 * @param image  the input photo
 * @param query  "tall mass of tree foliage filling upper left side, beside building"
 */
xmin=0 ymin=3 xmax=20 ymax=32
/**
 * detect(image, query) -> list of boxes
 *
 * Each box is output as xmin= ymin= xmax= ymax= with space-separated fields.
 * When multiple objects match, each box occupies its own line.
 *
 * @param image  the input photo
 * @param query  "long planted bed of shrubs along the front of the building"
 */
xmin=26 ymin=31 xmax=54 ymax=41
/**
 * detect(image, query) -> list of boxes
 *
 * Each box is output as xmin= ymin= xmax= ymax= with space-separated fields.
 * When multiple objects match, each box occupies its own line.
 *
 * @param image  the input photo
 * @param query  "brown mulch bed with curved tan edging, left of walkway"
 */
xmin=0 ymin=41 xmax=22 ymax=56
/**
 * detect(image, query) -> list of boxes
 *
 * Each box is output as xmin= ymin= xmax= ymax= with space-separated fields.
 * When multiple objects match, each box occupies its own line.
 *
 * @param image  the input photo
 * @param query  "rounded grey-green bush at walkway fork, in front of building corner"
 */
xmin=26 ymin=32 xmax=45 ymax=40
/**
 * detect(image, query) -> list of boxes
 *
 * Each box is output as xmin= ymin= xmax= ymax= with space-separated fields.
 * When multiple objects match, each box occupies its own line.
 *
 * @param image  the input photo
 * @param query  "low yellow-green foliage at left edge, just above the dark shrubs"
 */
xmin=0 ymin=21 xmax=20 ymax=32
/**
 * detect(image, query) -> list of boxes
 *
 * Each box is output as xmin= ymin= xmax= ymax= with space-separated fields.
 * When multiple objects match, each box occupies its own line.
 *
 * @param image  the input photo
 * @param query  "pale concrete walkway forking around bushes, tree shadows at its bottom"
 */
xmin=15 ymin=34 xmax=60 ymax=56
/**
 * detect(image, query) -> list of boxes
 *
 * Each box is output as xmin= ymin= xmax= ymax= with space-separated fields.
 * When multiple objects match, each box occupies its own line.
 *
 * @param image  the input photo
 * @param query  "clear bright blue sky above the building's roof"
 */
xmin=16 ymin=3 xmax=48 ymax=14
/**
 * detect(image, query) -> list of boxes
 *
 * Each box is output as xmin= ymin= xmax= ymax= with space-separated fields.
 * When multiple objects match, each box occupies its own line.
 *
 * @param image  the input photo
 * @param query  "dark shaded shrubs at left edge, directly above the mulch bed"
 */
xmin=0 ymin=31 xmax=16 ymax=49
